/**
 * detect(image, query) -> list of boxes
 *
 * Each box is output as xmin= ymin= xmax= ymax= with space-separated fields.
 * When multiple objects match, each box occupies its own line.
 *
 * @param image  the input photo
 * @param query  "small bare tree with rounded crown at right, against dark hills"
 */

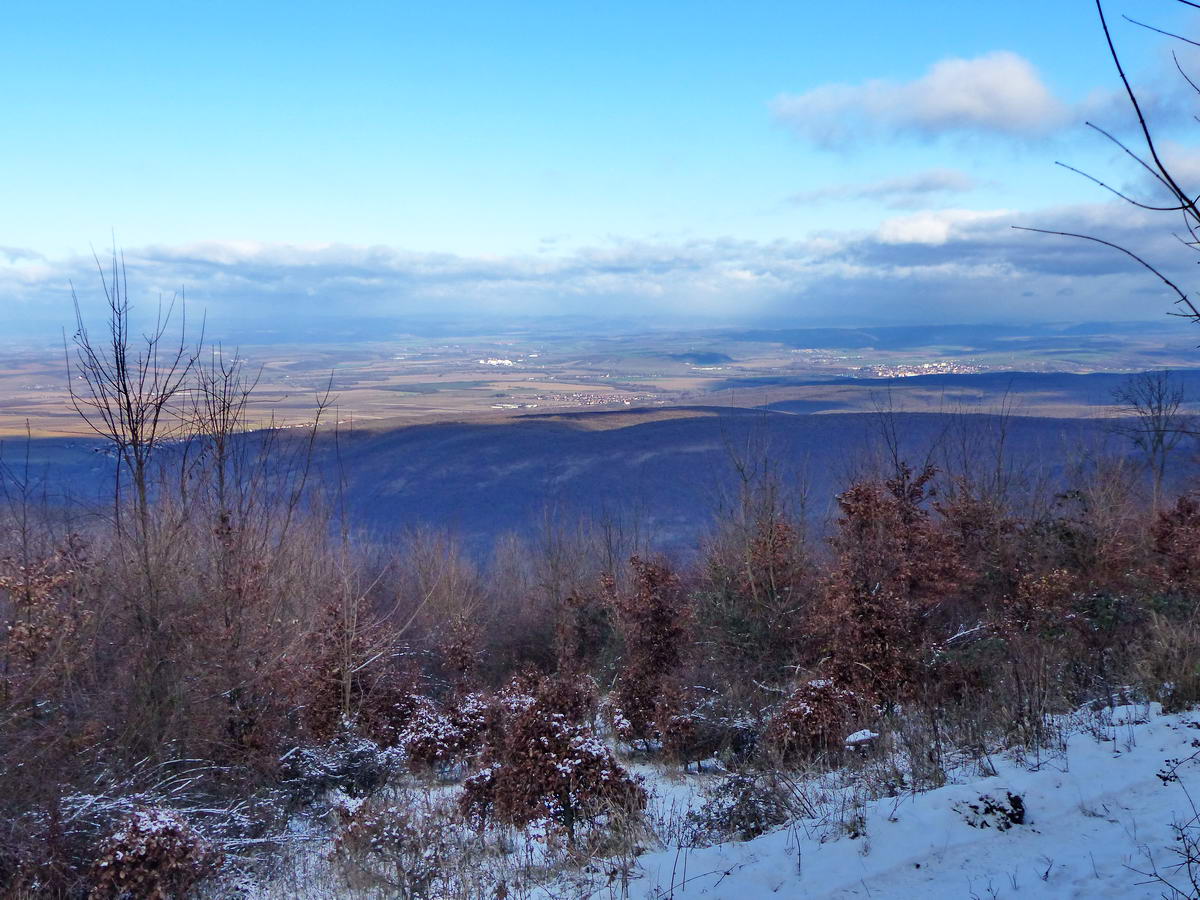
xmin=1112 ymin=370 xmax=1189 ymax=512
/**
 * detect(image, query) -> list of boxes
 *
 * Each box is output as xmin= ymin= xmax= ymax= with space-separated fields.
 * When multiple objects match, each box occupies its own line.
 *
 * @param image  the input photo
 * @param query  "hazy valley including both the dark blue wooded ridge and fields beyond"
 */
xmin=9 ymin=324 xmax=1200 ymax=554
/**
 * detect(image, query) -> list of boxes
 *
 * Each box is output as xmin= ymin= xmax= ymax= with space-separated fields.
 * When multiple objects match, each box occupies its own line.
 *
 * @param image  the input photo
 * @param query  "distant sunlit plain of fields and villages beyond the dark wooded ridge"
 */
xmin=0 ymin=322 xmax=1195 ymax=436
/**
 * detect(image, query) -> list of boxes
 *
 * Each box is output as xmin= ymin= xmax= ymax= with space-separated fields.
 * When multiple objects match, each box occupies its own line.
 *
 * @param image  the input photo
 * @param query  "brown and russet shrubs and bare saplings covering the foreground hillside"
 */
xmin=0 ymin=357 xmax=1200 ymax=898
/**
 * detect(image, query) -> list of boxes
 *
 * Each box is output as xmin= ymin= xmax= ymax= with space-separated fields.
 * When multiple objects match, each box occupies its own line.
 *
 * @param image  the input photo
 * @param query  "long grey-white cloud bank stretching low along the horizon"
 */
xmin=0 ymin=205 xmax=1194 ymax=340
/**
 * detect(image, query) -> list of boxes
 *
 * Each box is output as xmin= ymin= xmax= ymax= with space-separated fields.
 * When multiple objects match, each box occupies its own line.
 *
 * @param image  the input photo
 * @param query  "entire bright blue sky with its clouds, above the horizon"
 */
xmin=0 ymin=0 xmax=1200 ymax=331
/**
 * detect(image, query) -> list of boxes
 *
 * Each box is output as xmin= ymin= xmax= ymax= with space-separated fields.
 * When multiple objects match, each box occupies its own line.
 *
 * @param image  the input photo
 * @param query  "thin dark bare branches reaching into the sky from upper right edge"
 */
xmin=1014 ymin=0 xmax=1200 ymax=323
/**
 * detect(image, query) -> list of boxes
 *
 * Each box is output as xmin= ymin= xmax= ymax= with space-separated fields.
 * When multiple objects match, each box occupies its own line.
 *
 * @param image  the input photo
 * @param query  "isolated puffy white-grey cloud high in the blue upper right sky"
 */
xmin=772 ymin=50 xmax=1072 ymax=146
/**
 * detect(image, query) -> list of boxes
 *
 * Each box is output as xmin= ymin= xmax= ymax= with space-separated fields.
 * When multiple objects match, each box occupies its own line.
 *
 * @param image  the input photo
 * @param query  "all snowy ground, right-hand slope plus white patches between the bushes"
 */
xmin=246 ymin=703 xmax=1200 ymax=900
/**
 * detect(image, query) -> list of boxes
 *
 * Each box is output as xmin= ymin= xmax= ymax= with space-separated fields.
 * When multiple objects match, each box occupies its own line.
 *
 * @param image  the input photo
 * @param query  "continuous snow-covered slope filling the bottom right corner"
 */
xmin=624 ymin=704 xmax=1200 ymax=900
